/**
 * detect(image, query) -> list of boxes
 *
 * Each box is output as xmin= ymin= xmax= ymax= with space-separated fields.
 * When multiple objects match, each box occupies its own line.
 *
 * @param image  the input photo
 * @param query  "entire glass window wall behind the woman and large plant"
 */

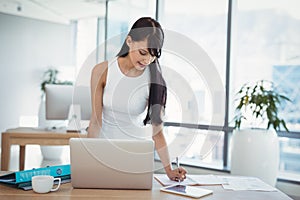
xmin=94 ymin=0 xmax=300 ymax=180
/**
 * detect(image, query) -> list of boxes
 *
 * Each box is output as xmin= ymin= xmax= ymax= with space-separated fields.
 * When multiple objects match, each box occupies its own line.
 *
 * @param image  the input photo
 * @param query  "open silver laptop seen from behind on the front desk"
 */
xmin=70 ymin=138 xmax=154 ymax=189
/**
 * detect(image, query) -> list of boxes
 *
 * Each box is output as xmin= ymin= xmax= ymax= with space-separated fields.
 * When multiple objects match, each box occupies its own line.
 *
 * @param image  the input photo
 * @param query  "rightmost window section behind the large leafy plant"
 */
xmin=229 ymin=0 xmax=300 ymax=177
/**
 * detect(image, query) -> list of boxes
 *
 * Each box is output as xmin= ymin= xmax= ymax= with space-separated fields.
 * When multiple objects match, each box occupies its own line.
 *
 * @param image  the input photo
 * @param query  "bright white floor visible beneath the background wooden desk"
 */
xmin=1 ymin=145 xmax=70 ymax=171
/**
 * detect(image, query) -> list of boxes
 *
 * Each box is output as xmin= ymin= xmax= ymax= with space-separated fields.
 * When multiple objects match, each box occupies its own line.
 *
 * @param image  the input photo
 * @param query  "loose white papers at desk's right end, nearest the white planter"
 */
xmin=220 ymin=176 xmax=277 ymax=192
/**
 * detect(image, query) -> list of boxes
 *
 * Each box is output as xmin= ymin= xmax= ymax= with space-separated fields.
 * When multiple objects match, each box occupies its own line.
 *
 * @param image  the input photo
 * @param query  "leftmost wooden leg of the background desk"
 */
xmin=1 ymin=133 xmax=10 ymax=171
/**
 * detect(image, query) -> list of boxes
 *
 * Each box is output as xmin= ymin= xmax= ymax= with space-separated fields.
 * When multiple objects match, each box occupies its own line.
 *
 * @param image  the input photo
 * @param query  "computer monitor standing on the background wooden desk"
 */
xmin=46 ymin=84 xmax=92 ymax=120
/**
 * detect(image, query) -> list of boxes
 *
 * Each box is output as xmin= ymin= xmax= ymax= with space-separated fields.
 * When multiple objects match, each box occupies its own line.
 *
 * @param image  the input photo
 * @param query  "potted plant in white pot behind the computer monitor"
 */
xmin=39 ymin=68 xmax=73 ymax=160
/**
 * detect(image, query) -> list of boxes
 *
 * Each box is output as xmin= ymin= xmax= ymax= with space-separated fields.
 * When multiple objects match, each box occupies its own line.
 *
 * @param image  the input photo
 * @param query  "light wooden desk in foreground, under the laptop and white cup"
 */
xmin=0 ymin=173 xmax=291 ymax=200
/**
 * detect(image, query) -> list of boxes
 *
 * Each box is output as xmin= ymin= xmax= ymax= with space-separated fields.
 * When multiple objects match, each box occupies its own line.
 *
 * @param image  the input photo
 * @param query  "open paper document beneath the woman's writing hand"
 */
xmin=154 ymin=174 xmax=227 ymax=186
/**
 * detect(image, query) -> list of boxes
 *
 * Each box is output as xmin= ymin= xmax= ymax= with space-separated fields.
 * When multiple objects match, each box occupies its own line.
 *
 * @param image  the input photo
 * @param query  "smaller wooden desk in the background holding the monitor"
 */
xmin=1 ymin=128 xmax=86 ymax=171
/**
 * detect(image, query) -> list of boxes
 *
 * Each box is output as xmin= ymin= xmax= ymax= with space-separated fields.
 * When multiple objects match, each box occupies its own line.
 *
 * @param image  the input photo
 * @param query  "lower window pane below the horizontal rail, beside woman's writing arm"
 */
xmin=164 ymin=126 xmax=224 ymax=169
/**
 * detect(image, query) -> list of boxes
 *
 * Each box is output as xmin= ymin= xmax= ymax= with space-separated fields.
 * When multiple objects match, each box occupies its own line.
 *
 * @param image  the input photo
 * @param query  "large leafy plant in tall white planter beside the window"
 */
xmin=231 ymin=80 xmax=290 ymax=186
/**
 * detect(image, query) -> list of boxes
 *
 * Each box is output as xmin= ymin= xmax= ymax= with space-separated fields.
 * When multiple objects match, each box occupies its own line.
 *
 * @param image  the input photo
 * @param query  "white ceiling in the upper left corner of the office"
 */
xmin=0 ymin=0 xmax=105 ymax=24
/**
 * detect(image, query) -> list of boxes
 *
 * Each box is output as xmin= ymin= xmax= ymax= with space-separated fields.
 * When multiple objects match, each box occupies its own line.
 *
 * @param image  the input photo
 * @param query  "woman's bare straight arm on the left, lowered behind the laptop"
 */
xmin=87 ymin=61 xmax=108 ymax=138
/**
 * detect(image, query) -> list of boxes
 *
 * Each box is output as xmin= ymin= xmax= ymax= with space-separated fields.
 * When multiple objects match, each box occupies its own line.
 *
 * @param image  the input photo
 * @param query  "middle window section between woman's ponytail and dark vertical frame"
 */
xmin=159 ymin=0 xmax=228 ymax=168
